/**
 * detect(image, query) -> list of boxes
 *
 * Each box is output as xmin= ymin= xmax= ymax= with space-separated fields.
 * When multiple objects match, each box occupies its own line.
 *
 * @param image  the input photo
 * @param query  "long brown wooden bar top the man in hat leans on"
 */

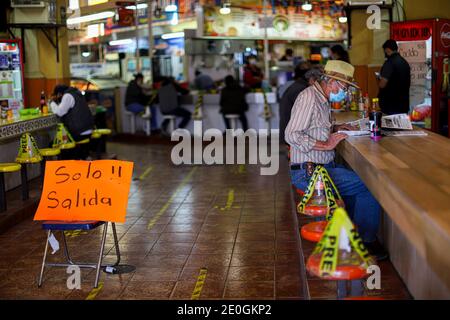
xmin=334 ymin=112 xmax=450 ymax=288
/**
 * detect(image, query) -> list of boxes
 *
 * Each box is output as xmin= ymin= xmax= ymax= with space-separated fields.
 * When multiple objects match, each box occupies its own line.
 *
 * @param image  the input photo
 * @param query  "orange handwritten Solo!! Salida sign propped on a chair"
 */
xmin=34 ymin=160 xmax=133 ymax=222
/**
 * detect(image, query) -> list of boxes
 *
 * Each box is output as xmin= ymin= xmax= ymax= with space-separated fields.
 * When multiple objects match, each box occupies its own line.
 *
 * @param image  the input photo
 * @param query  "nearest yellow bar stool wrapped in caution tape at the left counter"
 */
xmin=16 ymin=133 xmax=42 ymax=201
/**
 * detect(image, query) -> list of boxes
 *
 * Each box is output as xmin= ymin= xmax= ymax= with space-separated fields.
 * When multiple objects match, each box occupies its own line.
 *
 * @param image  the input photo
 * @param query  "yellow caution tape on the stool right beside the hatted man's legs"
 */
xmin=297 ymin=166 xmax=342 ymax=220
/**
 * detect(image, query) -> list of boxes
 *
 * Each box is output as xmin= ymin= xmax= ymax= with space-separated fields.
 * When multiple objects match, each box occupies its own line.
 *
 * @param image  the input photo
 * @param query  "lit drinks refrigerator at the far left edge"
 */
xmin=0 ymin=39 xmax=25 ymax=112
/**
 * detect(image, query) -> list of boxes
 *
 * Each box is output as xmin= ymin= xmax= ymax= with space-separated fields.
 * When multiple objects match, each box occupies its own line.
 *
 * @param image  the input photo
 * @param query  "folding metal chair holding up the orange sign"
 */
xmin=38 ymin=221 xmax=120 ymax=288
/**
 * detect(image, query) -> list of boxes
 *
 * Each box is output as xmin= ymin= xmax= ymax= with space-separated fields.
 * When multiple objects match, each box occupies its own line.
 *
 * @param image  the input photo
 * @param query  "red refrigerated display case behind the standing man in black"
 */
xmin=390 ymin=19 xmax=450 ymax=135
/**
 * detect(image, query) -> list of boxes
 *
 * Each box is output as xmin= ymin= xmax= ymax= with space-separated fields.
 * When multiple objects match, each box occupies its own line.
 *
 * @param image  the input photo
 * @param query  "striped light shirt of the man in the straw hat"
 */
xmin=285 ymin=82 xmax=334 ymax=164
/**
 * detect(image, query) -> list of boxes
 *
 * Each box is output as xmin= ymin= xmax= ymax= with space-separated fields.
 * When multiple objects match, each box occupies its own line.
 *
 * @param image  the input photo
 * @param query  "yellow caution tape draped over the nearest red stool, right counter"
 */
xmin=312 ymin=208 xmax=373 ymax=277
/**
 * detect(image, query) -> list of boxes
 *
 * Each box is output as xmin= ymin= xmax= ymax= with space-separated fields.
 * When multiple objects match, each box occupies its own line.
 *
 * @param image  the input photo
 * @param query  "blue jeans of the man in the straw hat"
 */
xmin=291 ymin=163 xmax=381 ymax=242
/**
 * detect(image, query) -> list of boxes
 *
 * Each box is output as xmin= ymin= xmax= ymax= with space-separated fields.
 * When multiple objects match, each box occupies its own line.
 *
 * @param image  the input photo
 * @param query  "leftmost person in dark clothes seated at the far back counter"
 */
xmin=125 ymin=73 xmax=150 ymax=118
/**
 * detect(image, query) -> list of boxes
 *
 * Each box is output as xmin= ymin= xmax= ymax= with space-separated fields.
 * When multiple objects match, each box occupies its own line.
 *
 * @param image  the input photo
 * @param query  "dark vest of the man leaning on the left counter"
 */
xmin=61 ymin=88 xmax=94 ymax=140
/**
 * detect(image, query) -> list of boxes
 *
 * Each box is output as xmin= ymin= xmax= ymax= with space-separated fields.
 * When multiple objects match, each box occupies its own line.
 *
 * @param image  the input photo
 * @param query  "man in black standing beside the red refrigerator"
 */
xmin=377 ymin=39 xmax=411 ymax=114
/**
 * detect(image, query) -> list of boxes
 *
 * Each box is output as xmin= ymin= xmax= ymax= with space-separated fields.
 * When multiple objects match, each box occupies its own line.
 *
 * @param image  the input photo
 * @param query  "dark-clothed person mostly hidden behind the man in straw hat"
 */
xmin=280 ymin=65 xmax=309 ymax=143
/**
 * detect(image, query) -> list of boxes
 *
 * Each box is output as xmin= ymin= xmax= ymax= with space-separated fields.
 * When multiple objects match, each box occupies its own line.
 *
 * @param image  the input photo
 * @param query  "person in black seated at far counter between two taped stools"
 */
xmin=220 ymin=75 xmax=248 ymax=131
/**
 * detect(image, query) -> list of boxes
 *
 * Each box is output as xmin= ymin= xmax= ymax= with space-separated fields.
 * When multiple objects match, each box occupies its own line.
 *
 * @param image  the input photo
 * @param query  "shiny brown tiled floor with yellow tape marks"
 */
xmin=0 ymin=143 xmax=409 ymax=299
